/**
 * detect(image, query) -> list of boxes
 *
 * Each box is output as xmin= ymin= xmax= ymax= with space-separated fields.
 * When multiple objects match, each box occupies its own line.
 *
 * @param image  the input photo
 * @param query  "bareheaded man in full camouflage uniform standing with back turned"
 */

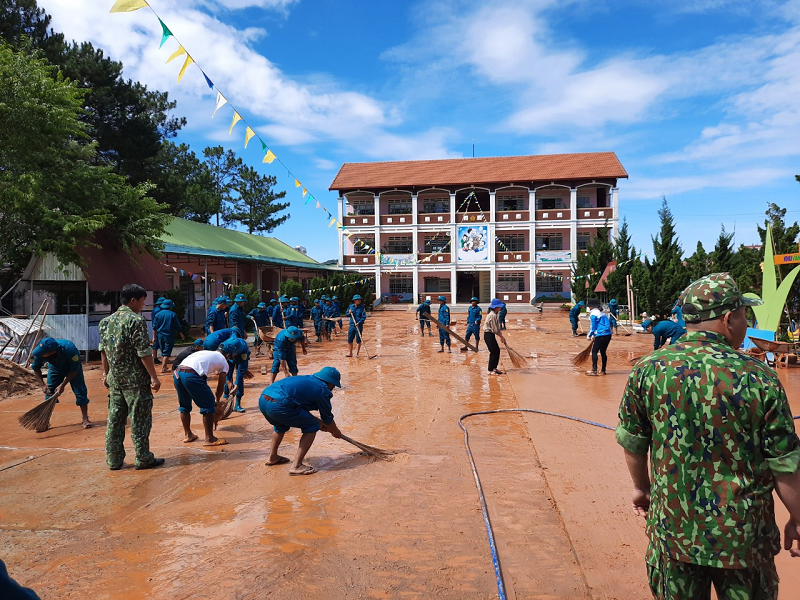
xmin=99 ymin=284 xmax=164 ymax=471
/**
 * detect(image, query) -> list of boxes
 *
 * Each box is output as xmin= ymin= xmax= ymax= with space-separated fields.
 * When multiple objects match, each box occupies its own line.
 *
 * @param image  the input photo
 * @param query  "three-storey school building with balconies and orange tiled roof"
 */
xmin=330 ymin=152 xmax=628 ymax=304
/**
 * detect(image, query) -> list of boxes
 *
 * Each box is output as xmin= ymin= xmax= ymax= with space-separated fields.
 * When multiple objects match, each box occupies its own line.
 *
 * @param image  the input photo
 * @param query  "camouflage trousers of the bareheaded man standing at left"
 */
xmin=106 ymin=386 xmax=155 ymax=469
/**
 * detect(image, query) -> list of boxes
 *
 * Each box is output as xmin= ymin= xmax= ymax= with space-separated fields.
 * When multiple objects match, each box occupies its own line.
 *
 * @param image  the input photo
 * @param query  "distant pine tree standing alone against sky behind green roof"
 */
xmin=222 ymin=165 xmax=289 ymax=233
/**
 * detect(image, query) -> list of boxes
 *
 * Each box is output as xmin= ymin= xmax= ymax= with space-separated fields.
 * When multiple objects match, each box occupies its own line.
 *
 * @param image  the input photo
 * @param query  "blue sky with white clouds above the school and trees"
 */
xmin=39 ymin=0 xmax=800 ymax=260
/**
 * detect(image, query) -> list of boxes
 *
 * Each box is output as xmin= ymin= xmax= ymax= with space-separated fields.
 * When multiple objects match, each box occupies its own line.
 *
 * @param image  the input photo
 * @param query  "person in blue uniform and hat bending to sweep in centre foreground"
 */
xmin=258 ymin=367 xmax=342 ymax=475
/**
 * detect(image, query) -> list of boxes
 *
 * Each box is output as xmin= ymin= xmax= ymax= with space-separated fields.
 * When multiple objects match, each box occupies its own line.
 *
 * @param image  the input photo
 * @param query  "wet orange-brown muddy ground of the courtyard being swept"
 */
xmin=0 ymin=311 xmax=800 ymax=600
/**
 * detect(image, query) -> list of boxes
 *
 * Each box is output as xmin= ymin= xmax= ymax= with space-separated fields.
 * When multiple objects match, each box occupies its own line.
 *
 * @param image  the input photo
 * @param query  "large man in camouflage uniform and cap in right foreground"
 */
xmin=616 ymin=273 xmax=800 ymax=600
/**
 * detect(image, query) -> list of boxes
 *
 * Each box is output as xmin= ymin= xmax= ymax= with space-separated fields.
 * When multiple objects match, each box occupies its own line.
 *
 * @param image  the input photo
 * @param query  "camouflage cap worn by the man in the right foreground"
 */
xmin=678 ymin=273 xmax=763 ymax=323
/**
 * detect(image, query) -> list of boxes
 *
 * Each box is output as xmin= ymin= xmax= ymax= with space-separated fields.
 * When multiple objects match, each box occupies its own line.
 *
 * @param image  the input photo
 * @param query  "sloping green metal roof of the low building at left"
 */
xmin=162 ymin=217 xmax=326 ymax=269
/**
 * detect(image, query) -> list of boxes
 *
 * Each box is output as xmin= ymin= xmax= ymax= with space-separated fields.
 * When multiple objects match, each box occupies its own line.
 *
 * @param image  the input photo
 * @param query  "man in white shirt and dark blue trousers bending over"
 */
xmin=173 ymin=350 xmax=229 ymax=446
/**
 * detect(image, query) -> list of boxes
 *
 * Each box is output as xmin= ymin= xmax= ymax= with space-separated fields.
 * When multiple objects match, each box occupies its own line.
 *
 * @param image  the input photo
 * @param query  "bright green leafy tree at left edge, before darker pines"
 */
xmin=0 ymin=44 xmax=167 ymax=288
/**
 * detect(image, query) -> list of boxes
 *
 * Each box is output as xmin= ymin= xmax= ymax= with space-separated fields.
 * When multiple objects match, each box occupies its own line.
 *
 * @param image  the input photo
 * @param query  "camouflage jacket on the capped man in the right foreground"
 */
xmin=616 ymin=331 xmax=800 ymax=569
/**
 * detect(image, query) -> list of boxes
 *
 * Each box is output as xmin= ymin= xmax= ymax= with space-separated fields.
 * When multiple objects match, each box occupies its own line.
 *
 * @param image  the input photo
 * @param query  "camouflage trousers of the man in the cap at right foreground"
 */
xmin=647 ymin=556 xmax=778 ymax=600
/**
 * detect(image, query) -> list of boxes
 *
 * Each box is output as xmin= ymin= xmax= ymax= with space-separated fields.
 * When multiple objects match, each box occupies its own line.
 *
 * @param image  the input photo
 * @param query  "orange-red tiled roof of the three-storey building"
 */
xmin=330 ymin=152 xmax=628 ymax=190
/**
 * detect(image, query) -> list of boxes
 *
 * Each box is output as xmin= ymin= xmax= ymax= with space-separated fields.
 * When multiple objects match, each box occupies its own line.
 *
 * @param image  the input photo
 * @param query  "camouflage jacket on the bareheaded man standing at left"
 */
xmin=99 ymin=306 xmax=153 ymax=388
